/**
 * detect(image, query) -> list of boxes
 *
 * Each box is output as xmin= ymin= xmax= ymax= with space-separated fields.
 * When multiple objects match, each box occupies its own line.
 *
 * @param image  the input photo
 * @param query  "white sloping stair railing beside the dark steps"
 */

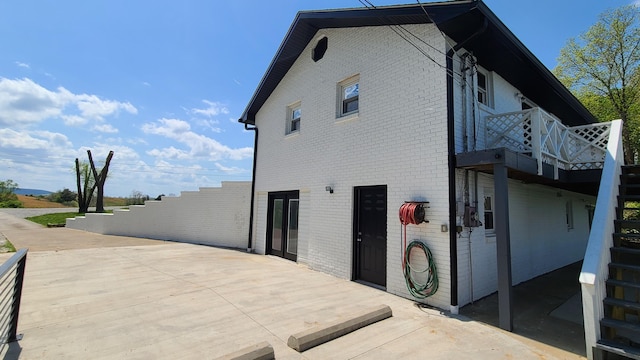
xmin=580 ymin=120 xmax=624 ymax=360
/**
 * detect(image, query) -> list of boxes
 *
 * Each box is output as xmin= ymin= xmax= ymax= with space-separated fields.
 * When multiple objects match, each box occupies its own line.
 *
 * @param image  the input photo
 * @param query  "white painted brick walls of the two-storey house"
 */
xmin=254 ymin=24 xmax=593 ymax=308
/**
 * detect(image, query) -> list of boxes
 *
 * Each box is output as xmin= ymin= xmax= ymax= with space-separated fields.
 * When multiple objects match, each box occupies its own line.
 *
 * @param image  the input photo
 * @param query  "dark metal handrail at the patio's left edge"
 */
xmin=0 ymin=249 xmax=28 ymax=351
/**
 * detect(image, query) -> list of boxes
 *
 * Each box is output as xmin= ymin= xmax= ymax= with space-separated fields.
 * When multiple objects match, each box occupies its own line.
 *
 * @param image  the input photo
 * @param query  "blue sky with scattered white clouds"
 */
xmin=0 ymin=0 xmax=632 ymax=197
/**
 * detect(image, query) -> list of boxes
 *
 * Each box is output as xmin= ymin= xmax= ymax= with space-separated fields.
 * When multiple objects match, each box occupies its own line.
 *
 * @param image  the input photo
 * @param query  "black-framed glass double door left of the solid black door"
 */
xmin=267 ymin=191 xmax=299 ymax=261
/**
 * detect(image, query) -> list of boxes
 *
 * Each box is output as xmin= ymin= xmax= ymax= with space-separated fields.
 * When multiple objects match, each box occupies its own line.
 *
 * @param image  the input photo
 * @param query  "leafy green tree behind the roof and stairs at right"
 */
xmin=554 ymin=5 xmax=640 ymax=163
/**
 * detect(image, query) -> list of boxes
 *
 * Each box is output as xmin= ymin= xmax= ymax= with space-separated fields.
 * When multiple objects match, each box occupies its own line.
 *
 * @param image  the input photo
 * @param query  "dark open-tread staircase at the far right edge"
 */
xmin=594 ymin=166 xmax=640 ymax=360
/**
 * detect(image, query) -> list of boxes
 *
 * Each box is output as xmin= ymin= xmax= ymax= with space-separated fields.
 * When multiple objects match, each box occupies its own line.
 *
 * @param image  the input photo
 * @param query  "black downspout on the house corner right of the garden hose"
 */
xmin=446 ymin=18 xmax=489 ymax=314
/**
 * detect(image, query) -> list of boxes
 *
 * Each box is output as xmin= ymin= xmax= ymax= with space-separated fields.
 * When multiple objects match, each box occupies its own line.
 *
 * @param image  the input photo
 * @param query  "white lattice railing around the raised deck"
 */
xmin=485 ymin=108 xmax=611 ymax=179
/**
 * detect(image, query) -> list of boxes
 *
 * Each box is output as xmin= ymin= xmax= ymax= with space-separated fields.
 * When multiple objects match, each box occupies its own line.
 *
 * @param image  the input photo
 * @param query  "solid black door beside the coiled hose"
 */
xmin=353 ymin=185 xmax=387 ymax=287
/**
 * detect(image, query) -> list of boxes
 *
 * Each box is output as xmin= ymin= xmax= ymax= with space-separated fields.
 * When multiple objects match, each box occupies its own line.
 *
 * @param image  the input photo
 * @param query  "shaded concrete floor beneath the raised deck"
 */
xmin=460 ymin=262 xmax=586 ymax=356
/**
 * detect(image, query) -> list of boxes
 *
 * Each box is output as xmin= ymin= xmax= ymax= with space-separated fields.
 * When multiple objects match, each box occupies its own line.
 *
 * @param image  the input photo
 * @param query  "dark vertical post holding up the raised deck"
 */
xmin=493 ymin=163 xmax=513 ymax=331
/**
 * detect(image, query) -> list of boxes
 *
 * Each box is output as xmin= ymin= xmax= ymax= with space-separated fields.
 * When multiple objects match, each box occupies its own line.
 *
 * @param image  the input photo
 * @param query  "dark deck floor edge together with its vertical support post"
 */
xmin=455 ymin=147 xmax=602 ymax=331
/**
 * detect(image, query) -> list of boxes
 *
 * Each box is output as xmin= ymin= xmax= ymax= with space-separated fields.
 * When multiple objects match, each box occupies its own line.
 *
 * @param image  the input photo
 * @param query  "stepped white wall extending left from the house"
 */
xmin=66 ymin=181 xmax=251 ymax=249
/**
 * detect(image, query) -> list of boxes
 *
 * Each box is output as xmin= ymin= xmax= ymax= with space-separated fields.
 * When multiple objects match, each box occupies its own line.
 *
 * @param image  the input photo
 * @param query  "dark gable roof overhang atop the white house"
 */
xmin=238 ymin=0 xmax=597 ymax=126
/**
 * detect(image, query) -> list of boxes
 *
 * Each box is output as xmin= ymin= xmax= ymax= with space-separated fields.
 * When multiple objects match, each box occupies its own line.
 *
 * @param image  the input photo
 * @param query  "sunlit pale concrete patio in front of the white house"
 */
xmin=0 ymin=212 xmax=582 ymax=359
